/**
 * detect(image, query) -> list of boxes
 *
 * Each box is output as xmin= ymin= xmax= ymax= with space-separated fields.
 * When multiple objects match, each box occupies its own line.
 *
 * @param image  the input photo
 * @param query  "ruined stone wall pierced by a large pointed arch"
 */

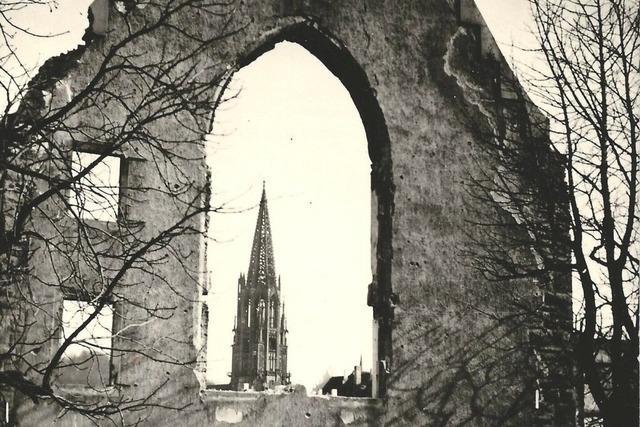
xmin=13 ymin=0 xmax=573 ymax=426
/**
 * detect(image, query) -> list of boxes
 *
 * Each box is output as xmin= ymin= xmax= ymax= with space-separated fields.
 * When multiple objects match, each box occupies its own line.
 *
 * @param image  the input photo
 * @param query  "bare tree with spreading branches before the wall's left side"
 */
xmin=0 ymin=0 xmax=241 ymax=423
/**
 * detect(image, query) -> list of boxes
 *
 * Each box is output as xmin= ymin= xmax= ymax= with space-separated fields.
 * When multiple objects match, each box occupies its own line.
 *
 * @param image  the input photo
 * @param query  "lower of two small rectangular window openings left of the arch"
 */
xmin=58 ymin=299 xmax=113 ymax=388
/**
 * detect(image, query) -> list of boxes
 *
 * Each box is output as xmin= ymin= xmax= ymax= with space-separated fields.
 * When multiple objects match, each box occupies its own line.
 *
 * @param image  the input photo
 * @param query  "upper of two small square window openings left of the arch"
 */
xmin=68 ymin=151 xmax=121 ymax=222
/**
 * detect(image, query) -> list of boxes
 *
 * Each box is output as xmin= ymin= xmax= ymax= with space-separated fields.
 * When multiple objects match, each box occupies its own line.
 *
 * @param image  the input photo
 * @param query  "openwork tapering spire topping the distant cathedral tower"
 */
xmin=247 ymin=181 xmax=276 ymax=287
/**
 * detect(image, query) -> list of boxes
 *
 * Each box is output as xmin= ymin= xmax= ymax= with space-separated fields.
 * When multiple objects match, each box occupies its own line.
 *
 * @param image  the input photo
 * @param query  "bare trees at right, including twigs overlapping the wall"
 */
xmin=460 ymin=0 xmax=640 ymax=426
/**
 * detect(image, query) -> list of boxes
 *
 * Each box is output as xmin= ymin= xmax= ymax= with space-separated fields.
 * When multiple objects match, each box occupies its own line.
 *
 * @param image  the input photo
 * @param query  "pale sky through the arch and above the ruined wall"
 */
xmin=6 ymin=0 xmax=531 ymax=389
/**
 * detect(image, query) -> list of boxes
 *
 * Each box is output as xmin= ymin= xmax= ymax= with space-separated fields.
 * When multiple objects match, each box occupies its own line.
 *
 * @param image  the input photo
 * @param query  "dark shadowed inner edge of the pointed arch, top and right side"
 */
xmin=211 ymin=20 xmax=395 ymax=397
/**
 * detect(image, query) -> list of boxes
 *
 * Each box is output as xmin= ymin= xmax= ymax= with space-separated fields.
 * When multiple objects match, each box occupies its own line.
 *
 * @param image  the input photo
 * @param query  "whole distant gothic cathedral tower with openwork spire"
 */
xmin=231 ymin=183 xmax=289 ymax=390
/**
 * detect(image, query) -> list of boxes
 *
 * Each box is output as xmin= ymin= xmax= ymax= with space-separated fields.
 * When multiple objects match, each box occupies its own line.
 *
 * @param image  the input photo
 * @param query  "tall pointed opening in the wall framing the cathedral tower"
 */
xmin=207 ymin=42 xmax=375 ymax=397
